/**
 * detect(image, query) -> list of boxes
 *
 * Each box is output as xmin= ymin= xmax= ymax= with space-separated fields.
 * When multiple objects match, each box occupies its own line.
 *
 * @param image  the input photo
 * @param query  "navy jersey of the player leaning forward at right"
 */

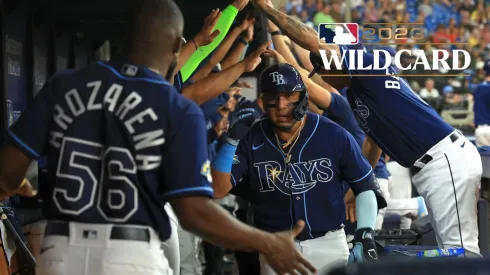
xmin=344 ymin=47 xmax=454 ymax=167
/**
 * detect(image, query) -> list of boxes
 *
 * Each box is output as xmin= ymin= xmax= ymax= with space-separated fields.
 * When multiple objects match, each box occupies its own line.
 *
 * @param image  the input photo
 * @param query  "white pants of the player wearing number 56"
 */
xmin=36 ymin=222 xmax=173 ymax=275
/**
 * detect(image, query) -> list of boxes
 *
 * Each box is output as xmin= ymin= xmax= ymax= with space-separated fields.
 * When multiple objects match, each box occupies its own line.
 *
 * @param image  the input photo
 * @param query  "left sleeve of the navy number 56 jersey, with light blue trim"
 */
xmin=7 ymin=76 xmax=55 ymax=160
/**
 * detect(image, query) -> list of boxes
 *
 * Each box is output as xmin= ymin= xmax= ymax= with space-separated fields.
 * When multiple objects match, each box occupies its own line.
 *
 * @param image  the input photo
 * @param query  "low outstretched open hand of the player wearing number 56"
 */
xmin=263 ymin=221 xmax=316 ymax=275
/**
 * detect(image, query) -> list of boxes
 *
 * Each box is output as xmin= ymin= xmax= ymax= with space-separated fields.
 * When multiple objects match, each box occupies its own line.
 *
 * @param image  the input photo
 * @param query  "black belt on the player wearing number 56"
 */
xmin=44 ymin=222 xmax=150 ymax=242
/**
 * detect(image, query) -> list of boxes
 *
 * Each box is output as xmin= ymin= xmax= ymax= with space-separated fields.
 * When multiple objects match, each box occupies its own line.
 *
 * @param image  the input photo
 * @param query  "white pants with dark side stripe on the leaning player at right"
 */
xmin=413 ymin=131 xmax=482 ymax=257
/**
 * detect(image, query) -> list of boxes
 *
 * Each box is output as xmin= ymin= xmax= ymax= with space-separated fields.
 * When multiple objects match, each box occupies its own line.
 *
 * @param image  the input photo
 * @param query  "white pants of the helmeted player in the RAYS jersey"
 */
xmin=259 ymin=229 xmax=349 ymax=275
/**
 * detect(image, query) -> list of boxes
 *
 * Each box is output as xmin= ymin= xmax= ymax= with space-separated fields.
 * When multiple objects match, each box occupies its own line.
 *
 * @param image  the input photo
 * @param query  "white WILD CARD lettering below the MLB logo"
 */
xmin=320 ymin=49 xmax=471 ymax=71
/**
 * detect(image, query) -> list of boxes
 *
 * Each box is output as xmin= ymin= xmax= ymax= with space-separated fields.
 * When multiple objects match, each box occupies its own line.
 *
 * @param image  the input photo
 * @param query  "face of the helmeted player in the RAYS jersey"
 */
xmin=262 ymin=92 xmax=300 ymax=131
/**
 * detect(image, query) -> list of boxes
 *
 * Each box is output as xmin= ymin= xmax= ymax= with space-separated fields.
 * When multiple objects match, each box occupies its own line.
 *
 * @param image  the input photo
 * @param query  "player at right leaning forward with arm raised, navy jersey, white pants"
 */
xmin=253 ymin=0 xmax=482 ymax=257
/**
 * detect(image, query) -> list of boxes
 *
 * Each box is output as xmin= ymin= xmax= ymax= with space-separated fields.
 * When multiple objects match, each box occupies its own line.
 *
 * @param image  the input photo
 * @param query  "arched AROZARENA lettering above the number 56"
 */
xmin=49 ymin=80 xmax=165 ymax=171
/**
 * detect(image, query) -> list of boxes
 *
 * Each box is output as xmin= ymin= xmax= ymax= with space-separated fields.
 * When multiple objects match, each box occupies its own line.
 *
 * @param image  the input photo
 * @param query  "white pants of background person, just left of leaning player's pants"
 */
xmin=386 ymin=161 xmax=412 ymax=229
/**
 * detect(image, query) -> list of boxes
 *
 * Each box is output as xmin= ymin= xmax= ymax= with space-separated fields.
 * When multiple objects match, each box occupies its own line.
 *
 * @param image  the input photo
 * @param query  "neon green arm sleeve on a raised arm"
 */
xmin=180 ymin=5 xmax=238 ymax=82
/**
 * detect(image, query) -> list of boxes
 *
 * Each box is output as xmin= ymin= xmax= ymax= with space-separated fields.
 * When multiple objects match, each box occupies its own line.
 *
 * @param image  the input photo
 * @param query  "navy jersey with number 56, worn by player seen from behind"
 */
xmin=9 ymin=62 xmax=213 ymax=243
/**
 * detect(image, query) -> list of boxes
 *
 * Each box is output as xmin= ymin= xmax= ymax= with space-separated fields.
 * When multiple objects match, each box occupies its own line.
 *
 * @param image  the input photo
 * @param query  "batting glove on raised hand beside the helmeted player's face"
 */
xmin=224 ymin=104 xmax=257 ymax=146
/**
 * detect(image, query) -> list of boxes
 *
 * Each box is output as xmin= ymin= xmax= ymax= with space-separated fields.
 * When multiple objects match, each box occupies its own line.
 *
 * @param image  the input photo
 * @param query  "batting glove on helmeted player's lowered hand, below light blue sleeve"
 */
xmin=349 ymin=228 xmax=378 ymax=263
